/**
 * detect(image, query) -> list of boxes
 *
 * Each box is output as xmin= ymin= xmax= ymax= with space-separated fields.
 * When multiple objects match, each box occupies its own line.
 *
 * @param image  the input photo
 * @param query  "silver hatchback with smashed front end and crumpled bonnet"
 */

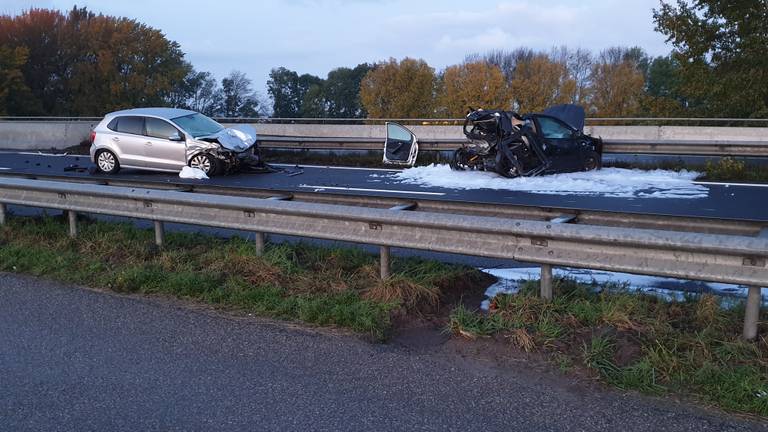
xmin=90 ymin=108 xmax=259 ymax=176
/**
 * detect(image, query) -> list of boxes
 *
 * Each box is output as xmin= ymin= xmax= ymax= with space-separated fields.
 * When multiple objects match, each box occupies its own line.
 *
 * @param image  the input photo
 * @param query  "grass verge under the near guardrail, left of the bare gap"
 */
xmin=0 ymin=217 xmax=477 ymax=340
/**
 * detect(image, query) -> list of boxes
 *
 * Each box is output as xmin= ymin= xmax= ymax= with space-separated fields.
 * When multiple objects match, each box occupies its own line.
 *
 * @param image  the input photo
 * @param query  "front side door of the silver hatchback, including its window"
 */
xmin=144 ymin=117 xmax=187 ymax=171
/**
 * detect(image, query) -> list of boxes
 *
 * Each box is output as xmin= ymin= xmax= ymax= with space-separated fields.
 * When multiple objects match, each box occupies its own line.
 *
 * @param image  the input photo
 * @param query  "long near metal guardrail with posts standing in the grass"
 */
xmin=0 ymin=178 xmax=768 ymax=339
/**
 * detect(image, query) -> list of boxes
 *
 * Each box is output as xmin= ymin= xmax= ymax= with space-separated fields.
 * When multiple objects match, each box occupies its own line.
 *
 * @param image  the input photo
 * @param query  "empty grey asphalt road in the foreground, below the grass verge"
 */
xmin=0 ymin=273 xmax=766 ymax=432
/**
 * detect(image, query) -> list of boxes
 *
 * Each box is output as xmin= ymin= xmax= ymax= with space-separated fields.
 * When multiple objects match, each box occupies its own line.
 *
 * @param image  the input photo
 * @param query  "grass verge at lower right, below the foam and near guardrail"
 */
xmin=449 ymin=279 xmax=768 ymax=416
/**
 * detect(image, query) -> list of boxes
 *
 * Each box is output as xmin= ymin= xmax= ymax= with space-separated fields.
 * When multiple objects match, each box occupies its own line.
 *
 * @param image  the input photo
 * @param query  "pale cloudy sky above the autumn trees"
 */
xmin=0 ymin=0 xmax=670 ymax=92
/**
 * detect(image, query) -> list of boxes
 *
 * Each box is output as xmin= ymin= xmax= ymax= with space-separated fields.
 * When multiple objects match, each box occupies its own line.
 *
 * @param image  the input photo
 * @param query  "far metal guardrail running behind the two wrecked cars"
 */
xmin=258 ymin=135 xmax=768 ymax=157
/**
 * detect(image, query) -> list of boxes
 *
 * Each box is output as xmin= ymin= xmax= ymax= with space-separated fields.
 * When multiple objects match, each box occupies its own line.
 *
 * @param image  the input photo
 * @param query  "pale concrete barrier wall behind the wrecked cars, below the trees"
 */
xmin=0 ymin=121 xmax=768 ymax=150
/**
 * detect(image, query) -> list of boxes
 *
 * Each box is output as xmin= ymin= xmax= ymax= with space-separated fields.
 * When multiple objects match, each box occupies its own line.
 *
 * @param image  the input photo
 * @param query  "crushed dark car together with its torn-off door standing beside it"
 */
xmin=384 ymin=105 xmax=603 ymax=177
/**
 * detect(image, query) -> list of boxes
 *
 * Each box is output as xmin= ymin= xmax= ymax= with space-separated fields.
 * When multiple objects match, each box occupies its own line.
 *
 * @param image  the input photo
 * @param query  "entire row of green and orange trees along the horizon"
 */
xmin=0 ymin=0 xmax=768 ymax=118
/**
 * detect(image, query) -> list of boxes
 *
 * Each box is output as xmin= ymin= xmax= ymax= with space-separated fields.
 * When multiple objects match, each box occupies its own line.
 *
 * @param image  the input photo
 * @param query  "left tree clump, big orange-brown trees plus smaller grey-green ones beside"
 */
xmin=0 ymin=8 xmax=268 ymax=117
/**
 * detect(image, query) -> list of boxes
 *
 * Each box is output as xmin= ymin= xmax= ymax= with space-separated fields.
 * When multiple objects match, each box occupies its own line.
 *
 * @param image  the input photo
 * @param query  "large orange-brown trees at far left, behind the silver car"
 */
xmin=0 ymin=8 xmax=191 ymax=116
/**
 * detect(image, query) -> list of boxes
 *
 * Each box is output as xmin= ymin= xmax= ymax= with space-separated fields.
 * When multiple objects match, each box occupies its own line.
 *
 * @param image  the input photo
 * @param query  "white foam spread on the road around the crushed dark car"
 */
xmin=390 ymin=165 xmax=709 ymax=199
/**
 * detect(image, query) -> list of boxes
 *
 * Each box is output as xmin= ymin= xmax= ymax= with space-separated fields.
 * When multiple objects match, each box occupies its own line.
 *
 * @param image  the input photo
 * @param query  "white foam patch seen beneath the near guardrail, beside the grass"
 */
xmin=480 ymin=267 xmax=768 ymax=310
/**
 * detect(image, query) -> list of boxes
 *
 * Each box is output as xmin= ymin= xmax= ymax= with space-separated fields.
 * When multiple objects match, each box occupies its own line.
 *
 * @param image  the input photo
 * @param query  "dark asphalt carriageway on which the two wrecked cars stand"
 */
xmin=0 ymin=153 xmax=768 ymax=221
